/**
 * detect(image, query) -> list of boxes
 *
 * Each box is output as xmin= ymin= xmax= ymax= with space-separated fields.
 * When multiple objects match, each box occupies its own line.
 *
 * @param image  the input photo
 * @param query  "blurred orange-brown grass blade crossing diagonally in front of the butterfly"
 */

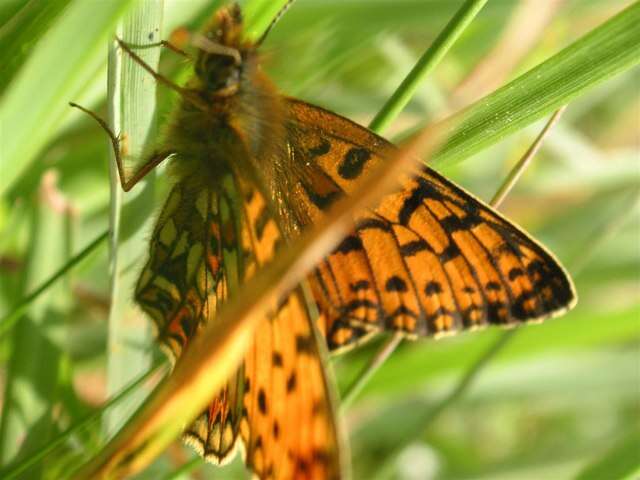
xmin=71 ymin=63 xmax=460 ymax=478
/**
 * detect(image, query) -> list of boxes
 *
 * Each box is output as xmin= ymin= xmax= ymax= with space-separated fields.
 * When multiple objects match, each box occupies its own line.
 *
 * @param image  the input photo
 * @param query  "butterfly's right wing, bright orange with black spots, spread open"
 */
xmin=288 ymin=99 xmax=575 ymax=348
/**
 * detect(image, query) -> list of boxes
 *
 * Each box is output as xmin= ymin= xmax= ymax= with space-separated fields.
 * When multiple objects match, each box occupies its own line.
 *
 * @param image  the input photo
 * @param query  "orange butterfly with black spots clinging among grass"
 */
xmin=92 ymin=1 xmax=575 ymax=478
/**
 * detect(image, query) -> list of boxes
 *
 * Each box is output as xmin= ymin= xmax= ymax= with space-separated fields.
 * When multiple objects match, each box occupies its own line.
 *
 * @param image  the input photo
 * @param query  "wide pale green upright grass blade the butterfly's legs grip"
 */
xmin=105 ymin=0 xmax=164 ymax=433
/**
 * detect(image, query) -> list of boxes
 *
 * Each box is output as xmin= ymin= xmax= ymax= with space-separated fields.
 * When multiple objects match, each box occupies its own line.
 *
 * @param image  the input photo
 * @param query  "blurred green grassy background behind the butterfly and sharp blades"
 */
xmin=0 ymin=0 xmax=640 ymax=480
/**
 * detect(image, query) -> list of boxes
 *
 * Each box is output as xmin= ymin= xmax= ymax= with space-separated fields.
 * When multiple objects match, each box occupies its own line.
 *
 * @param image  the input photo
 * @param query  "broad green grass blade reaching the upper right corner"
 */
xmin=431 ymin=2 xmax=640 ymax=164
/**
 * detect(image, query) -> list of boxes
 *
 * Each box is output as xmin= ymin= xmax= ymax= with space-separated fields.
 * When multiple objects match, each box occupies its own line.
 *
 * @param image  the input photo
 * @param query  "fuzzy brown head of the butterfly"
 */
xmin=193 ymin=4 xmax=253 ymax=97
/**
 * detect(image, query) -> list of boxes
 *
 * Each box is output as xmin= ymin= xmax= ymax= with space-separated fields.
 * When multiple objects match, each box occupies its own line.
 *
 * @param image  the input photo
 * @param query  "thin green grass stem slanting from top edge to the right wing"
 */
xmin=369 ymin=0 xmax=487 ymax=132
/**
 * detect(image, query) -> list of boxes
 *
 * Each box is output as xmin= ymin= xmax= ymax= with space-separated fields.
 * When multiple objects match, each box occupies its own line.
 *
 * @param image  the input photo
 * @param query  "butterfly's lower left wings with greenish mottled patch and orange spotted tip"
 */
xmin=136 ymin=175 xmax=348 ymax=478
